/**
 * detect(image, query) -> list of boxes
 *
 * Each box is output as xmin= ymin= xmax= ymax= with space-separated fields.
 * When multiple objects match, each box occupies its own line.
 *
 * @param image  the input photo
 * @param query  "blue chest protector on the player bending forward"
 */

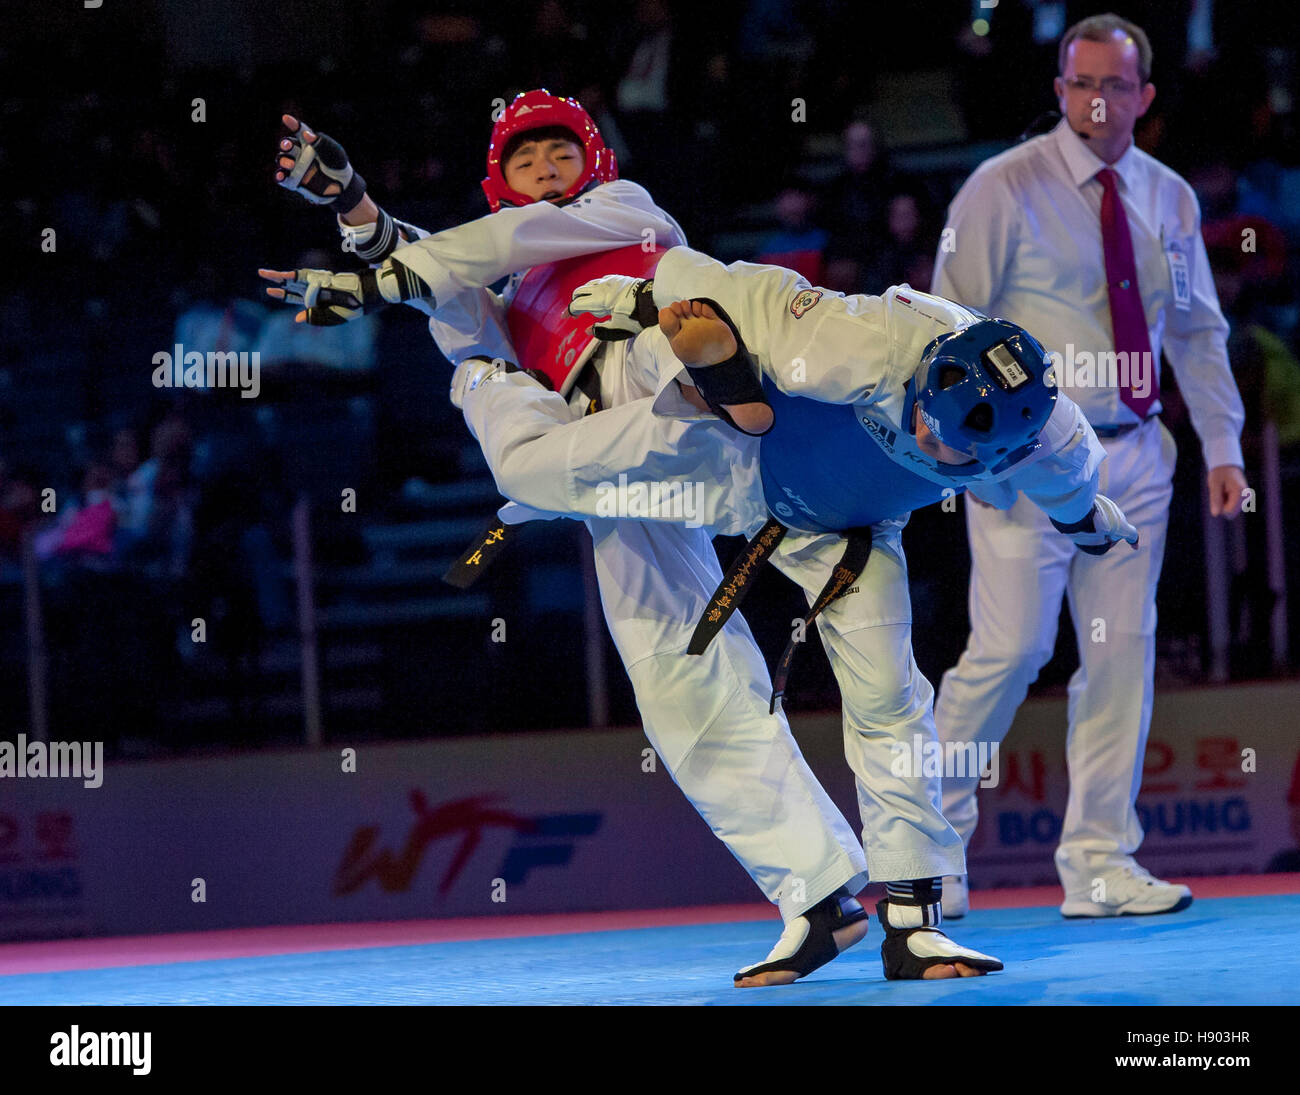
xmin=759 ymin=377 xmax=966 ymax=532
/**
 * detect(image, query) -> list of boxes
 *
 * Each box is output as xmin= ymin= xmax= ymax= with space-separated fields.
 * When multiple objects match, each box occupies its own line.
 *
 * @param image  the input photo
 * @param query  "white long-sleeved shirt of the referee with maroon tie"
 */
xmin=933 ymin=118 xmax=1245 ymax=468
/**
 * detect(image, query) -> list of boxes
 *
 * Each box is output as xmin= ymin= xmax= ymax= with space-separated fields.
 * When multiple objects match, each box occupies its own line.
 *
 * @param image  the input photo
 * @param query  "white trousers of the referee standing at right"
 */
xmin=935 ymin=419 xmax=1177 ymax=892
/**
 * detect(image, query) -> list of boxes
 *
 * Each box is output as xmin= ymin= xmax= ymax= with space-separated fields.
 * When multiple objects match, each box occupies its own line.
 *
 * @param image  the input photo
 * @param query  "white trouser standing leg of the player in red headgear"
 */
xmin=586 ymin=519 xmax=866 ymax=921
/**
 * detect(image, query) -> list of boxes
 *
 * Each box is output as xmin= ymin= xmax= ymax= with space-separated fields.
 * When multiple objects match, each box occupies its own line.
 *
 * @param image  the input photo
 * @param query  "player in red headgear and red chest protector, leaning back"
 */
xmin=263 ymin=90 xmax=883 ymax=987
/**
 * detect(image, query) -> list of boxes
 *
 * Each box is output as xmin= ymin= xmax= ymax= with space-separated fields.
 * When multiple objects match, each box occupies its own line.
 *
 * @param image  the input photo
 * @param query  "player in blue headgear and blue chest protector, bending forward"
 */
xmin=452 ymin=247 xmax=1138 ymax=977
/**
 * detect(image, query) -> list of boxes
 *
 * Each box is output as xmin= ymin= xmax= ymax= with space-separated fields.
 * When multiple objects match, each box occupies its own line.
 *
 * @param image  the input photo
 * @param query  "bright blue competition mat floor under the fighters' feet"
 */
xmin=0 ymin=895 xmax=1300 ymax=1005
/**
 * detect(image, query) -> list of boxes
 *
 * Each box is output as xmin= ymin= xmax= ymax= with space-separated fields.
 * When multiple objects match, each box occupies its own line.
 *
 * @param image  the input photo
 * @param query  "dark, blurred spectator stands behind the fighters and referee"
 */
xmin=0 ymin=0 xmax=1300 ymax=756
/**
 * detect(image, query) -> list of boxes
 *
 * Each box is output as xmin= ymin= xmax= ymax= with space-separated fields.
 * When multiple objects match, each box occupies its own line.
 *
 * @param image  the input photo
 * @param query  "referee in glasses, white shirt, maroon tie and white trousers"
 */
xmin=933 ymin=14 xmax=1245 ymax=917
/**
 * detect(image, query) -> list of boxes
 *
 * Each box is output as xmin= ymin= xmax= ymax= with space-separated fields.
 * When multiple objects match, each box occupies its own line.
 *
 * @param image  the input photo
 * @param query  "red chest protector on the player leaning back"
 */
xmin=506 ymin=243 xmax=667 ymax=395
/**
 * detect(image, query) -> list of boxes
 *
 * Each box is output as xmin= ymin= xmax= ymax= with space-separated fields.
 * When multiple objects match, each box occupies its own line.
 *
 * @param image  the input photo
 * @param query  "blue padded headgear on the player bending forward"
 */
xmin=917 ymin=320 xmax=1056 ymax=468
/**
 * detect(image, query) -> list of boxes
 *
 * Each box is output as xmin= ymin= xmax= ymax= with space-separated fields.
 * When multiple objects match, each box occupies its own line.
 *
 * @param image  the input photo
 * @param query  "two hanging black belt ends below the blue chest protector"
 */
xmin=686 ymin=518 xmax=871 ymax=714
